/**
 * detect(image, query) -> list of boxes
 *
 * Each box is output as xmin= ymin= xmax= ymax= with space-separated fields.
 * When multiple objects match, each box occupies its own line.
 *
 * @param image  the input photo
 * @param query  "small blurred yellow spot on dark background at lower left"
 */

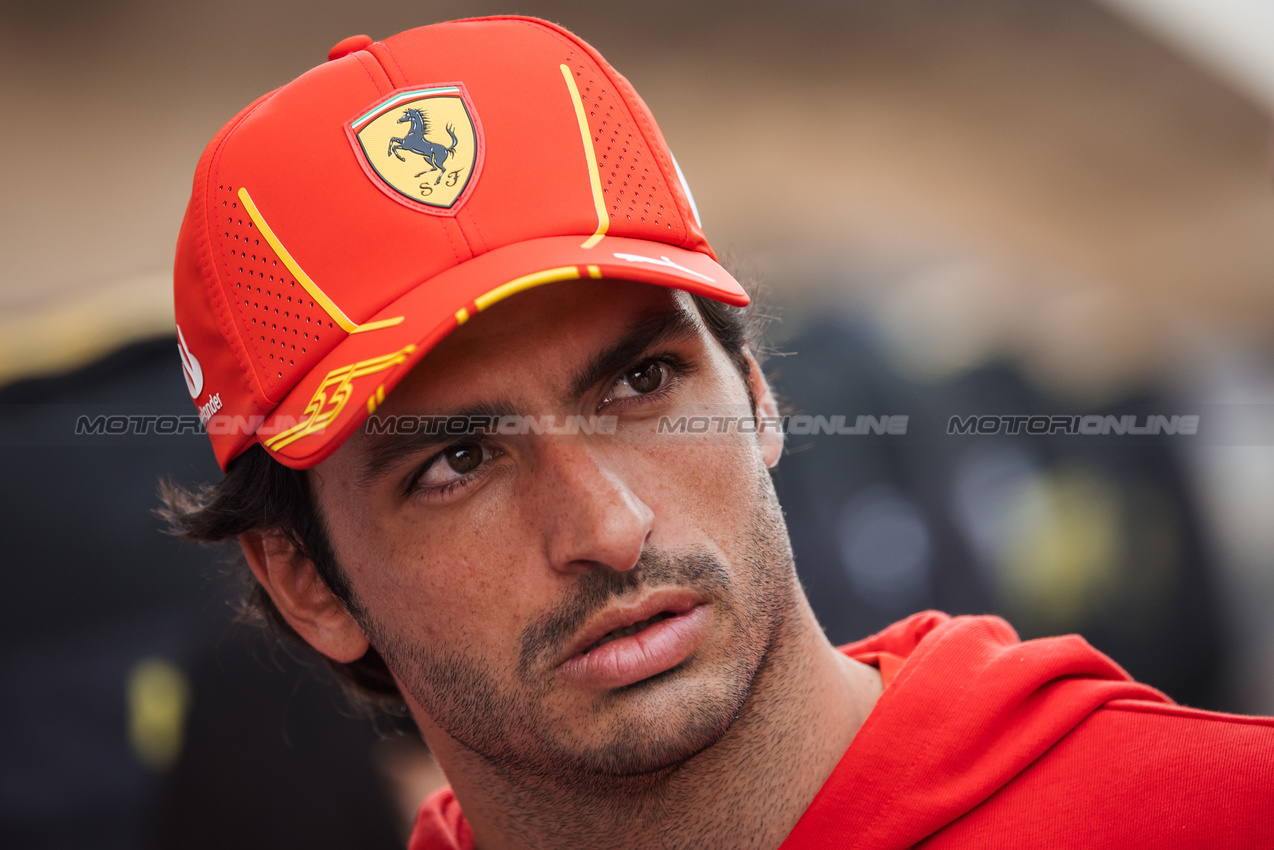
xmin=126 ymin=658 xmax=190 ymax=771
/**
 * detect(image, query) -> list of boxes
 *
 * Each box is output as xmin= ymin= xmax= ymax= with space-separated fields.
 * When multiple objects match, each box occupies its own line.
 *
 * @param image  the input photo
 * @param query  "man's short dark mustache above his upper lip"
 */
xmin=517 ymin=549 xmax=730 ymax=677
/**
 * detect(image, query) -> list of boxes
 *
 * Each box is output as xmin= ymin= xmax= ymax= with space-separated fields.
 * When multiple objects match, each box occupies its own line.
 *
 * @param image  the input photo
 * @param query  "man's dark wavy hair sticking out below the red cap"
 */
xmin=158 ymin=289 xmax=768 ymax=714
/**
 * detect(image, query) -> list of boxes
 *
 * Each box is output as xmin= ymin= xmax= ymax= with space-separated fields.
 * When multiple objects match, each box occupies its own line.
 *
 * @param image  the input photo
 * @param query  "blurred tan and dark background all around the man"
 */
xmin=0 ymin=0 xmax=1274 ymax=847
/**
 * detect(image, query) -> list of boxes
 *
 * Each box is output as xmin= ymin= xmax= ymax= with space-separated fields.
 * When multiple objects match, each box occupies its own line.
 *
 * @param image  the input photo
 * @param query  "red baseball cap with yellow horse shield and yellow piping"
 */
xmin=173 ymin=17 xmax=748 ymax=469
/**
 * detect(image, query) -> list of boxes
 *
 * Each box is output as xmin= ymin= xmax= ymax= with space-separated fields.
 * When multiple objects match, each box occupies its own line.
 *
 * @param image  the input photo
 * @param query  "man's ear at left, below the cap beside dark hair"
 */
xmin=238 ymin=531 xmax=368 ymax=664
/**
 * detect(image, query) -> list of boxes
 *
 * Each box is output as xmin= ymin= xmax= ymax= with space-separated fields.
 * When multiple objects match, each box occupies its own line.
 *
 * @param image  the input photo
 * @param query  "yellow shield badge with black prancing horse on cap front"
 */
xmin=348 ymin=83 xmax=482 ymax=212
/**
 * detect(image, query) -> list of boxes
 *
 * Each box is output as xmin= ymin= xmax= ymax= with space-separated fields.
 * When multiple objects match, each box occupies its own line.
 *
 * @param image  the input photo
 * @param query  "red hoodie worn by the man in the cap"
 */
xmin=410 ymin=612 xmax=1274 ymax=850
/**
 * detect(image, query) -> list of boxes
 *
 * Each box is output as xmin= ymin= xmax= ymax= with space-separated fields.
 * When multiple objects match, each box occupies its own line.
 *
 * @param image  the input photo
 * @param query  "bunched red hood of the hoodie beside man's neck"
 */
xmin=781 ymin=612 xmax=1171 ymax=850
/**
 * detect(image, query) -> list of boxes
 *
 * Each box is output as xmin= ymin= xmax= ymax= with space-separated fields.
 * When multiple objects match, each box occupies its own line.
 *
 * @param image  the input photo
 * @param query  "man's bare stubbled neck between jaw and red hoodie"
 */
xmin=417 ymin=593 xmax=880 ymax=850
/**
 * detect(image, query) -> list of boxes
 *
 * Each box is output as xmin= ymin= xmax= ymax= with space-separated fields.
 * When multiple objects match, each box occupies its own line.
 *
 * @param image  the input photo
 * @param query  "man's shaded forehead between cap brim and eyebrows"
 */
xmin=385 ymin=280 xmax=707 ymax=412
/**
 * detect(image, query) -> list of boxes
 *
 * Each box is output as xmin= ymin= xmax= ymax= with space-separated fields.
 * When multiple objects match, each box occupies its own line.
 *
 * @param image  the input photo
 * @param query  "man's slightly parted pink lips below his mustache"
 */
xmin=557 ymin=589 xmax=708 ymax=688
